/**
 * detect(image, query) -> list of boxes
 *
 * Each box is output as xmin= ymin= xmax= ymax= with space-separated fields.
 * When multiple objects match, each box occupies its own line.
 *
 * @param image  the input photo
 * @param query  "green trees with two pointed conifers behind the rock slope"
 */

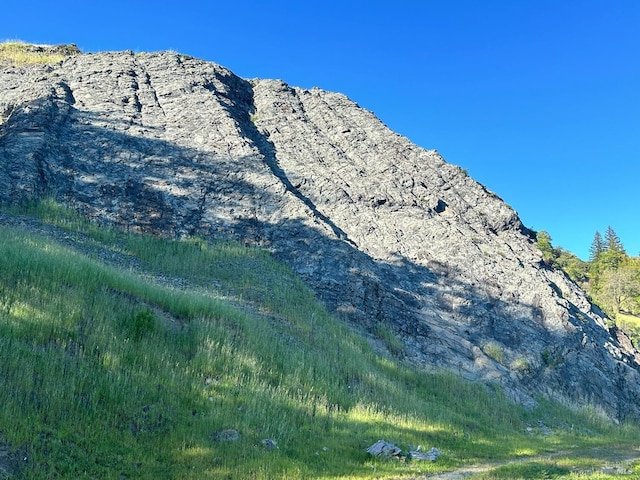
xmin=537 ymin=227 xmax=640 ymax=319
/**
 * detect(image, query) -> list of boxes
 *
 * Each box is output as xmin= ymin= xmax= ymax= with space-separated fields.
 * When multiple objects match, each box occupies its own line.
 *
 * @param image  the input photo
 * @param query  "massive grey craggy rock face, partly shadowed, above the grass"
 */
xmin=0 ymin=52 xmax=640 ymax=419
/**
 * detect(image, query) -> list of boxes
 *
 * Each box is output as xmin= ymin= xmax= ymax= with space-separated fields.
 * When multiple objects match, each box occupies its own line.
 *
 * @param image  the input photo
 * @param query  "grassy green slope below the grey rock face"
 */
xmin=0 ymin=202 xmax=639 ymax=479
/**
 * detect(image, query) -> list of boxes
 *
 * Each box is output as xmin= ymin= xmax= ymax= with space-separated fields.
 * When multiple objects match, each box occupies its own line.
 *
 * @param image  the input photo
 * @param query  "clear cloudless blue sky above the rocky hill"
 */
xmin=0 ymin=0 xmax=640 ymax=258
